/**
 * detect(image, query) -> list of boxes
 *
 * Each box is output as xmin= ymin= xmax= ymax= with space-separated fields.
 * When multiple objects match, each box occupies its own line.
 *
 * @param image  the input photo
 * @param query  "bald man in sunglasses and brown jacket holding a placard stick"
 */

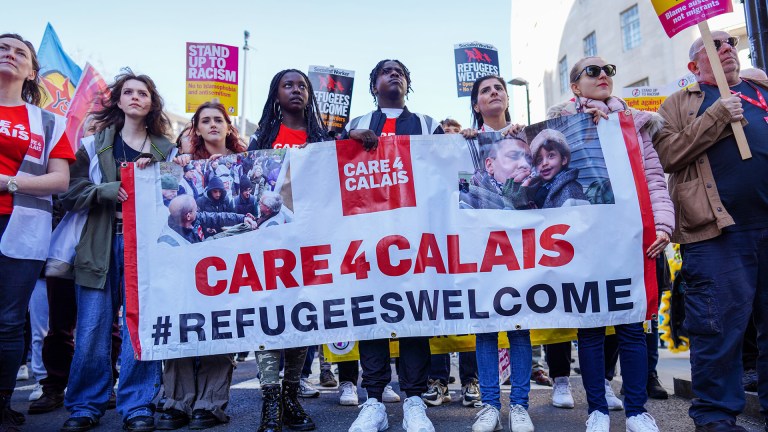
xmin=654 ymin=31 xmax=768 ymax=432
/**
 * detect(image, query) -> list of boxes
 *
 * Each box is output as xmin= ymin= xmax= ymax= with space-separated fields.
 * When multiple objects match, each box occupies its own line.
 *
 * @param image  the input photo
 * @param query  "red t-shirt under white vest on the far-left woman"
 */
xmin=0 ymin=105 xmax=75 ymax=215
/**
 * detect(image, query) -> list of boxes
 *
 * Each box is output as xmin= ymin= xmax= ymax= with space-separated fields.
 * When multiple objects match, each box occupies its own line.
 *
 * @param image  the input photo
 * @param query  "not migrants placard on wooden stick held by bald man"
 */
xmin=651 ymin=0 xmax=752 ymax=159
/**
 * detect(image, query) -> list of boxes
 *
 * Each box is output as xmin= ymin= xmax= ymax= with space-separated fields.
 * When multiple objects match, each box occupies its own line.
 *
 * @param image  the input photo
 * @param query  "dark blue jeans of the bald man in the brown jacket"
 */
xmin=682 ymin=228 xmax=768 ymax=425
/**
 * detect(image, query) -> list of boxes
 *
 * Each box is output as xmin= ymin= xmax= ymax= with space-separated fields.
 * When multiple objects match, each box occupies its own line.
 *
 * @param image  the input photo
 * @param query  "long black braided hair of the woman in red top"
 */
xmin=256 ymin=69 xmax=329 ymax=150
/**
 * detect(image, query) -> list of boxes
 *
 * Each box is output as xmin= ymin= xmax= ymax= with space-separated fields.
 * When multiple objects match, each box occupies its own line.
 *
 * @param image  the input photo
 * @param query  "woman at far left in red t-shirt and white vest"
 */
xmin=0 ymin=34 xmax=75 ymax=430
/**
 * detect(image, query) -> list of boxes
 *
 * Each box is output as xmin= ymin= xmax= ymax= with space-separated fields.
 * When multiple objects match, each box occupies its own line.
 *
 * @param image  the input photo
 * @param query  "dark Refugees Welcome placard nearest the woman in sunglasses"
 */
xmin=453 ymin=42 xmax=499 ymax=97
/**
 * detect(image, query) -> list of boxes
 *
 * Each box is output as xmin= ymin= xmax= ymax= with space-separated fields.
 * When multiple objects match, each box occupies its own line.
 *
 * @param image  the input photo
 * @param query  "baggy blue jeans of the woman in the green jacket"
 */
xmin=64 ymin=235 xmax=162 ymax=421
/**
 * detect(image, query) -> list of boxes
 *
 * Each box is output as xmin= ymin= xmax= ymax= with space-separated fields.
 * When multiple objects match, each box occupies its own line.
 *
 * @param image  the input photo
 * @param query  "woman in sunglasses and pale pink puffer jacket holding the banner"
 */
xmin=547 ymin=57 xmax=675 ymax=432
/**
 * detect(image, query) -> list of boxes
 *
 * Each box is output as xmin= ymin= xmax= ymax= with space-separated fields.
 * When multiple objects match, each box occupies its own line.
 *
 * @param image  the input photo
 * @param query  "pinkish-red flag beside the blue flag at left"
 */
xmin=66 ymin=63 xmax=109 ymax=150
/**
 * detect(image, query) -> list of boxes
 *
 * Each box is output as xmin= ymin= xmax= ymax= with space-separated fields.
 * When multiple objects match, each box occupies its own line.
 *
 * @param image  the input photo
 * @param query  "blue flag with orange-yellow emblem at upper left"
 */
xmin=37 ymin=23 xmax=83 ymax=118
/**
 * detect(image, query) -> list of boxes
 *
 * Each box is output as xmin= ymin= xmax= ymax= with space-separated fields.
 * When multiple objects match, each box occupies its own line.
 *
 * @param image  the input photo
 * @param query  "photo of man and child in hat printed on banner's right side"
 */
xmin=459 ymin=114 xmax=615 ymax=210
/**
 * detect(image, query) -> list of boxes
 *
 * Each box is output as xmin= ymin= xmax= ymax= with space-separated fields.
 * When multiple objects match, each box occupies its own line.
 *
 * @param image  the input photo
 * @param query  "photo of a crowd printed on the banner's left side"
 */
xmin=157 ymin=149 xmax=293 ymax=246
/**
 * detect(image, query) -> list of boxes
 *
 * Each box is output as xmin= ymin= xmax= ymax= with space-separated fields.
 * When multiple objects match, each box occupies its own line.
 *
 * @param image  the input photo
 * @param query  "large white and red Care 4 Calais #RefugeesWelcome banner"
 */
xmin=123 ymin=113 xmax=656 ymax=359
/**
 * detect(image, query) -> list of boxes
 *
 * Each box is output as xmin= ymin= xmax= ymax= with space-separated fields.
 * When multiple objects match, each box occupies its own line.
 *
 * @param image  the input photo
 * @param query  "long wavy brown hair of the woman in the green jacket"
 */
xmin=93 ymin=68 xmax=171 ymax=136
